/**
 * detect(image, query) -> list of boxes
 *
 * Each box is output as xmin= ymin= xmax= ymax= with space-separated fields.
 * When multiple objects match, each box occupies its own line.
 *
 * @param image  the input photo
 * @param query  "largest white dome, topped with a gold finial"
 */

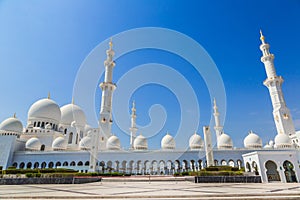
xmin=28 ymin=99 xmax=61 ymax=123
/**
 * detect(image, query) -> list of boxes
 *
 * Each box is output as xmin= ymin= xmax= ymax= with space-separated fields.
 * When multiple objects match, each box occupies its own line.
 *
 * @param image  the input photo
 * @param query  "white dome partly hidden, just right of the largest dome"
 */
xmin=60 ymin=103 xmax=86 ymax=126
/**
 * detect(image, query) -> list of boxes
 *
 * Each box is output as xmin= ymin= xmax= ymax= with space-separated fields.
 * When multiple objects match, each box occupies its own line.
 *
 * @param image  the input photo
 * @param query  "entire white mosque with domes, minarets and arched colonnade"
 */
xmin=0 ymin=33 xmax=300 ymax=182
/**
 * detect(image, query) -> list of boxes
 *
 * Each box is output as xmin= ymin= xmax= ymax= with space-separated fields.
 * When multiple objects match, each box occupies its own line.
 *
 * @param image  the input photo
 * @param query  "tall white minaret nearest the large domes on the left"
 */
xmin=99 ymin=40 xmax=116 ymax=143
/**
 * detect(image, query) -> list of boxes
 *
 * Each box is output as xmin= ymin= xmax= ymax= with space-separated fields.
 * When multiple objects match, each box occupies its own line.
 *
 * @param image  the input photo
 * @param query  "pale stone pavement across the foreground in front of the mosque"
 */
xmin=0 ymin=177 xmax=300 ymax=200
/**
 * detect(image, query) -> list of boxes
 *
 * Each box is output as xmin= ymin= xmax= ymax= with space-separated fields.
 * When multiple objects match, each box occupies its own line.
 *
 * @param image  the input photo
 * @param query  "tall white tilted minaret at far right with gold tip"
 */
xmin=260 ymin=31 xmax=295 ymax=136
